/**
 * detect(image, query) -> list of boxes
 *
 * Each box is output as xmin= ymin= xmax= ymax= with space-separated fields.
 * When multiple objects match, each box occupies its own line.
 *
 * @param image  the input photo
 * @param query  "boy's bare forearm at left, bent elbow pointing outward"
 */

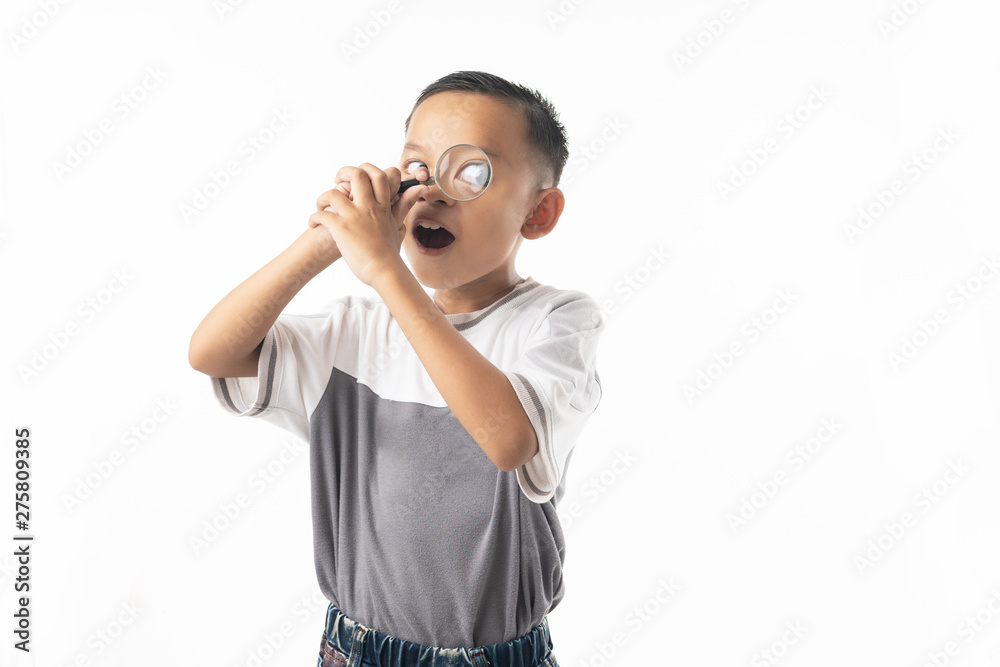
xmin=188 ymin=227 xmax=340 ymax=377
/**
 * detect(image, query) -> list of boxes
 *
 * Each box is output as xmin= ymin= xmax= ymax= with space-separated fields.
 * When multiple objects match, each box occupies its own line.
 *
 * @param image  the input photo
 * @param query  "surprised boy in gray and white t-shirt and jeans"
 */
xmin=189 ymin=72 xmax=604 ymax=667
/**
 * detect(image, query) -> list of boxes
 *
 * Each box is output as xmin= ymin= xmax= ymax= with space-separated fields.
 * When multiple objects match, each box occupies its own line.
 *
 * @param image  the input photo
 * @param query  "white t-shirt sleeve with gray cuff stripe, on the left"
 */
xmin=212 ymin=304 xmax=346 ymax=442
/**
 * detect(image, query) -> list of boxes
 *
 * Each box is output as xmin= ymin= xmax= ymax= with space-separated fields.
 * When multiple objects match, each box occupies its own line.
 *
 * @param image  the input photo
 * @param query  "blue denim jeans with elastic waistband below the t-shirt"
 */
xmin=316 ymin=602 xmax=559 ymax=667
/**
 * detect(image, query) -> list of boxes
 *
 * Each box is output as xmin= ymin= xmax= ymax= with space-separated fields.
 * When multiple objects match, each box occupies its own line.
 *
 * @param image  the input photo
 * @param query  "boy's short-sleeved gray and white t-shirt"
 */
xmin=212 ymin=277 xmax=604 ymax=648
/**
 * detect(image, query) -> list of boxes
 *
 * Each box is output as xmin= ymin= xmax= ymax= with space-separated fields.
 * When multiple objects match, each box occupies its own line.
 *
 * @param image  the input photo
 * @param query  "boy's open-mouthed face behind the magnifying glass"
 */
xmin=399 ymin=91 xmax=544 ymax=289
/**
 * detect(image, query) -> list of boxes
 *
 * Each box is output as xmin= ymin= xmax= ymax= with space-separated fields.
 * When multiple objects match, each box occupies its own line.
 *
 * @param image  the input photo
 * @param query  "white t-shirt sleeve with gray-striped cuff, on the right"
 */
xmin=504 ymin=293 xmax=604 ymax=503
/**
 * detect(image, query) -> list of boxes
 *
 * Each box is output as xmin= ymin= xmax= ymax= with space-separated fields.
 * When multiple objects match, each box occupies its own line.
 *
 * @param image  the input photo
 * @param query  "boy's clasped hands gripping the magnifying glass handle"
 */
xmin=309 ymin=162 xmax=426 ymax=285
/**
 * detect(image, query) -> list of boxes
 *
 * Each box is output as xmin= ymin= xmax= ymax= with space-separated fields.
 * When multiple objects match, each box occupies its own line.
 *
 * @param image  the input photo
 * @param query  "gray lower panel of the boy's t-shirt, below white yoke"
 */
xmin=310 ymin=368 xmax=564 ymax=647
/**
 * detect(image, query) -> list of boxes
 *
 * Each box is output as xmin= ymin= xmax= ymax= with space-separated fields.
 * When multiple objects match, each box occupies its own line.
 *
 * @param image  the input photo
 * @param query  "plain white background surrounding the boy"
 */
xmin=0 ymin=0 xmax=1000 ymax=667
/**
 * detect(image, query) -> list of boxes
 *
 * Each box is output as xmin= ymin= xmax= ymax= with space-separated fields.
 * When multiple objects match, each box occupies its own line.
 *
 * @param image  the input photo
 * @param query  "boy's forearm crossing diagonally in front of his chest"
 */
xmin=372 ymin=260 xmax=538 ymax=471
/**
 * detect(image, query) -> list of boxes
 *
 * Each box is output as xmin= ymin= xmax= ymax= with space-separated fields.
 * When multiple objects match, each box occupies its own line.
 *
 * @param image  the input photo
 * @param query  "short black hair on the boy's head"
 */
xmin=403 ymin=71 xmax=569 ymax=187
